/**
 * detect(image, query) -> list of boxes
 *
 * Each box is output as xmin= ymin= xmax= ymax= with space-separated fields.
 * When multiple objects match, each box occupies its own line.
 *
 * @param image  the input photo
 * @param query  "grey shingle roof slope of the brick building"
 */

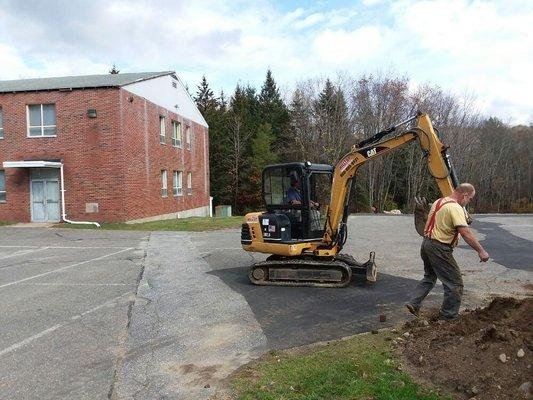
xmin=0 ymin=71 xmax=174 ymax=93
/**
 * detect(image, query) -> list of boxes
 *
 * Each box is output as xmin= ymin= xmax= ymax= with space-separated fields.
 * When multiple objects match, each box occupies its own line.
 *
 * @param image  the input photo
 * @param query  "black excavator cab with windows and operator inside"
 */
xmin=259 ymin=162 xmax=334 ymax=243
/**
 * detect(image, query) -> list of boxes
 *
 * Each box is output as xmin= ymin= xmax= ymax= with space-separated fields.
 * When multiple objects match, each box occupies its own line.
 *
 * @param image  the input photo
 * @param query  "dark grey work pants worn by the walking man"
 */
xmin=411 ymin=238 xmax=463 ymax=318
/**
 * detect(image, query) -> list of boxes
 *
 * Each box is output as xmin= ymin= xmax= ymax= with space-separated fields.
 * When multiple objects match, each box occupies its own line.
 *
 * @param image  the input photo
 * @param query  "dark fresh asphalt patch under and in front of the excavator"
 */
xmin=210 ymin=267 xmax=424 ymax=349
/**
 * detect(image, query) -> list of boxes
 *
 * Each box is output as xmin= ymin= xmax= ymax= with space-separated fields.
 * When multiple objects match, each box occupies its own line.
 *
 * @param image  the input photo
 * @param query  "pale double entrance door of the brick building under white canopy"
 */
xmin=30 ymin=168 xmax=59 ymax=222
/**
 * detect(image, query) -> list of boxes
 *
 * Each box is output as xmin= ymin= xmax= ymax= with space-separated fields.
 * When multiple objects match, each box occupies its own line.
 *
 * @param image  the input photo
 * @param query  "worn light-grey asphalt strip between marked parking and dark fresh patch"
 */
xmin=111 ymin=232 xmax=266 ymax=400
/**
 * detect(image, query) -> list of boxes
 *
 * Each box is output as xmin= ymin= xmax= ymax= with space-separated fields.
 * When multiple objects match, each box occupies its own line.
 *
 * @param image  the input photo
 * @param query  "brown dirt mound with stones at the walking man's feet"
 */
xmin=398 ymin=298 xmax=533 ymax=400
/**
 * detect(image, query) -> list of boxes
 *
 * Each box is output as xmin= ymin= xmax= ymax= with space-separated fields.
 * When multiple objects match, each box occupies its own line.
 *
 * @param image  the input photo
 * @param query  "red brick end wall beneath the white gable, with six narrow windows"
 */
xmin=120 ymin=89 xmax=209 ymax=220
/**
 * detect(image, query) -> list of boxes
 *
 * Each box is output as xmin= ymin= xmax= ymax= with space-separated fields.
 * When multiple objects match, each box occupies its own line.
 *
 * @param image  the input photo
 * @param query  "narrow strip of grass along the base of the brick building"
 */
xmin=54 ymin=216 xmax=243 ymax=231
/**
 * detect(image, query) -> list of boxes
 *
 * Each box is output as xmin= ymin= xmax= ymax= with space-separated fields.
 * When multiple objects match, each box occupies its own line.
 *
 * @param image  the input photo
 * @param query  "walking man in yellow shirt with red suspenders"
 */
xmin=405 ymin=183 xmax=489 ymax=319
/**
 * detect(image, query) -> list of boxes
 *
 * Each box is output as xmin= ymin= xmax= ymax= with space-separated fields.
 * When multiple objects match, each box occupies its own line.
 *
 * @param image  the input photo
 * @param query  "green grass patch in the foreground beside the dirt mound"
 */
xmin=230 ymin=332 xmax=449 ymax=400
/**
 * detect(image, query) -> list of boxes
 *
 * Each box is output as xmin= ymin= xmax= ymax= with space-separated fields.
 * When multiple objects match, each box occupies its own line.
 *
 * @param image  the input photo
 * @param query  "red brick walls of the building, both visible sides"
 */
xmin=0 ymin=88 xmax=209 ymax=222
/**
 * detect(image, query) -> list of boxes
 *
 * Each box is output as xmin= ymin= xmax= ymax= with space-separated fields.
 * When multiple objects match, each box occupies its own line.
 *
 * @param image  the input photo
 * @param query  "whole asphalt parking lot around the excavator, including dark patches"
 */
xmin=0 ymin=215 xmax=533 ymax=399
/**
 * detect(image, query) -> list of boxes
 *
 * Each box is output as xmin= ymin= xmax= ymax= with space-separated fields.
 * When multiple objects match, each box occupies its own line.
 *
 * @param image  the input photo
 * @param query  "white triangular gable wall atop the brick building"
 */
xmin=122 ymin=75 xmax=207 ymax=127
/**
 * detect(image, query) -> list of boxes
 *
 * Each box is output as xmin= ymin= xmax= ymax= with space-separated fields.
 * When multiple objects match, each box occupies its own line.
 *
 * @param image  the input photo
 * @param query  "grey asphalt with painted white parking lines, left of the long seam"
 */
xmin=0 ymin=228 xmax=147 ymax=399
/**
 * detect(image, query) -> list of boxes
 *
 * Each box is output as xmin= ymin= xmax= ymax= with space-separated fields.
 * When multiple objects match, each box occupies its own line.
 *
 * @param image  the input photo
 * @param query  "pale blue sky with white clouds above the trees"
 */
xmin=0 ymin=0 xmax=533 ymax=124
